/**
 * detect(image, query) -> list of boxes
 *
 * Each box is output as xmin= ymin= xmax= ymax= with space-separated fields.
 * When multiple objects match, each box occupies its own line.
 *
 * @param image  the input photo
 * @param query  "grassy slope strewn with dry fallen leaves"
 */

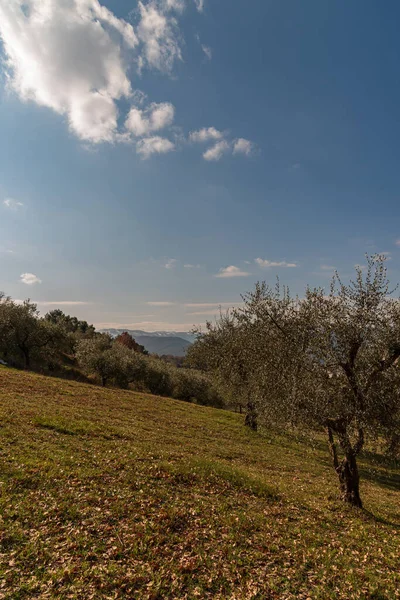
xmin=0 ymin=368 xmax=400 ymax=600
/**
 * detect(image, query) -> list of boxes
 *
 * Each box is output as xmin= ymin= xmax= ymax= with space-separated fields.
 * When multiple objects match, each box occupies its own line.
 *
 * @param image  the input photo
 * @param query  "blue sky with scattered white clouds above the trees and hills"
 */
xmin=0 ymin=0 xmax=400 ymax=331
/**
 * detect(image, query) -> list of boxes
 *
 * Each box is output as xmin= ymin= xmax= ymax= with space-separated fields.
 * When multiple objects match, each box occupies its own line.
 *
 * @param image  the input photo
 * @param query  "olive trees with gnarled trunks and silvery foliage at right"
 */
xmin=188 ymin=256 xmax=400 ymax=507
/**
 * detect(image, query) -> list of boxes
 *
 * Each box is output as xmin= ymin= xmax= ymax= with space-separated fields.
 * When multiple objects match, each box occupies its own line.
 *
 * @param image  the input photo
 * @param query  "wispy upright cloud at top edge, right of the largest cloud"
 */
xmin=137 ymin=0 xmax=182 ymax=73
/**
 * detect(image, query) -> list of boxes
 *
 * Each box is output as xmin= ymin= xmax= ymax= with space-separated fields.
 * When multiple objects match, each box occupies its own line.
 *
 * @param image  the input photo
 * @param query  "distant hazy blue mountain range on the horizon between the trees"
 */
xmin=101 ymin=329 xmax=196 ymax=356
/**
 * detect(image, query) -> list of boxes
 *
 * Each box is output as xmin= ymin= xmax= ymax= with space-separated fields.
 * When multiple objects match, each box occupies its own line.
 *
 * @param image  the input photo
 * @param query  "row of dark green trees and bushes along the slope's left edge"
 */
xmin=0 ymin=294 xmax=224 ymax=407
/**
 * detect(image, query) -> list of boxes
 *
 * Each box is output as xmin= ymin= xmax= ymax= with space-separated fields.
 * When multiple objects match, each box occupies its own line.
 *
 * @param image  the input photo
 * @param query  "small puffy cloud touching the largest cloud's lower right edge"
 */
xmin=125 ymin=102 xmax=175 ymax=137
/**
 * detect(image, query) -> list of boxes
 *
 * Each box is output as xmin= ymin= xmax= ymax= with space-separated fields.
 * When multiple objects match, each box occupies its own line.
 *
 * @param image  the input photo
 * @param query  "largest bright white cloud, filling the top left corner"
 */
xmin=0 ymin=0 xmax=138 ymax=142
